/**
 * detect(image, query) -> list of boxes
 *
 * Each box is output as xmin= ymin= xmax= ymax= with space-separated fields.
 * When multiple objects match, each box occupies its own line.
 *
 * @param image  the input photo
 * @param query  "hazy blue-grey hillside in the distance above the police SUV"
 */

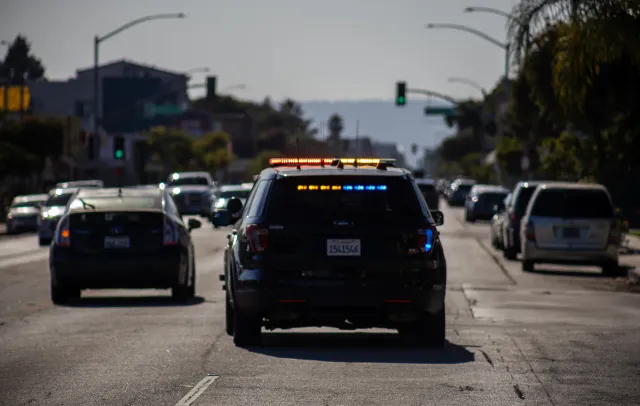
xmin=300 ymin=99 xmax=455 ymax=162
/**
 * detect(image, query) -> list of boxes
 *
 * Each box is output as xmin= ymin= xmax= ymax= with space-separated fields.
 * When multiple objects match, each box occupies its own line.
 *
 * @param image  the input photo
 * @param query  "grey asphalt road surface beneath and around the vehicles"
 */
xmin=0 ymin=207 xmax=640 ymax=406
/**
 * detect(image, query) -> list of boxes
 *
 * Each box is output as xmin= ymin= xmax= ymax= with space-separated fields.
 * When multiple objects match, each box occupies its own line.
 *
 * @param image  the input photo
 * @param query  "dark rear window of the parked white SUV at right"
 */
xmin=531 ymin=189 xmax=614 ymax=218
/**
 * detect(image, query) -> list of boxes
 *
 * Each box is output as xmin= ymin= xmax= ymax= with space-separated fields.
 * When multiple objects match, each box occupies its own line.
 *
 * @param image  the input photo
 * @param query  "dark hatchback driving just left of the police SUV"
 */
xmin=49 ymin=188 xmax=201 ymax=304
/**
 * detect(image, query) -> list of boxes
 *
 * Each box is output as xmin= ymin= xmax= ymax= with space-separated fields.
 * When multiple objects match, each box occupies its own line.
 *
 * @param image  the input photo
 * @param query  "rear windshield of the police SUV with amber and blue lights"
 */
xmin=267 ymin=176 xmax=428 ymax=227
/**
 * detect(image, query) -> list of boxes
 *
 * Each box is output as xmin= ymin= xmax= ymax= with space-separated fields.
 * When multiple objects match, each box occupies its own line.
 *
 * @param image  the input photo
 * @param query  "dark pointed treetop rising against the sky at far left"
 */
xmin=0 ymin=35 xmax=45 ymax=84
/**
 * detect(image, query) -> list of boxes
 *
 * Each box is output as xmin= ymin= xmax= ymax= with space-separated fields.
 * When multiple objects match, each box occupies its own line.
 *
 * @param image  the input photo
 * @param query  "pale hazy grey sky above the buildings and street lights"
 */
xmin=0 ymin=0 xmax=516 ymax=101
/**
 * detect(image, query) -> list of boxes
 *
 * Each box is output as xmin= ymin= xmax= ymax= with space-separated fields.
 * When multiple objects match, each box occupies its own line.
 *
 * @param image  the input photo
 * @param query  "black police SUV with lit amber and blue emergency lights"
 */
xmin=220 ymin=158 xmax=447 ymax=347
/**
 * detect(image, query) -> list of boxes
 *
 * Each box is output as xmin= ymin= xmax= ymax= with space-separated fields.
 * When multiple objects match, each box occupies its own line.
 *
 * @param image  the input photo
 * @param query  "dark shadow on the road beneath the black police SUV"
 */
xmin=247 ymin=333 xmax=475 ymax=364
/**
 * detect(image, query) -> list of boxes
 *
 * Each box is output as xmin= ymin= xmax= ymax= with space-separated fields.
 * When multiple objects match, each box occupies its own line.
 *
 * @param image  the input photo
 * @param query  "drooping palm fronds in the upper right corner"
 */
xmin=508 ymin=0 xmax=640 ymax=104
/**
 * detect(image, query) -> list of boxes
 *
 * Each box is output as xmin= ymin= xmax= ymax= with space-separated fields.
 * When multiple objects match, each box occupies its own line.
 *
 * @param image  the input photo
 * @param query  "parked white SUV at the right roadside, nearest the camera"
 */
xmin=520 ymin=182 xmax=620 ymax=275
